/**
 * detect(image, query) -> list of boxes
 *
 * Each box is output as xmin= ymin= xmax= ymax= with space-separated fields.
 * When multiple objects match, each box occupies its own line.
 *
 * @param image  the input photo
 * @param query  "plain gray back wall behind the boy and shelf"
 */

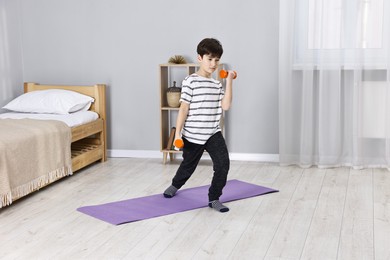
xmin=0 ymin=0 xmax=279 ymax=154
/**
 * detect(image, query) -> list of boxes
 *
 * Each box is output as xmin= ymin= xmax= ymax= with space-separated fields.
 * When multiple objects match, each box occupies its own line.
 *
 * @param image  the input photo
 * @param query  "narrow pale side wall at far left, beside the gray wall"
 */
xmin=0 ymin=0 xmax=23 ymax=110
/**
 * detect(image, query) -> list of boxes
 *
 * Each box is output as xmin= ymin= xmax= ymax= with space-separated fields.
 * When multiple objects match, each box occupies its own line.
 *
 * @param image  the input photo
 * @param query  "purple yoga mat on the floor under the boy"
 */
xmin=77 ymin=180 xmax=277 ymax=225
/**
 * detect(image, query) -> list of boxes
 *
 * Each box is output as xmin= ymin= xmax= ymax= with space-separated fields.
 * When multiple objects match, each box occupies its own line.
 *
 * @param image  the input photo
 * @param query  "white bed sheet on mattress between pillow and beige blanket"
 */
xmin=0 ymin=111 xmax=99 ymax=127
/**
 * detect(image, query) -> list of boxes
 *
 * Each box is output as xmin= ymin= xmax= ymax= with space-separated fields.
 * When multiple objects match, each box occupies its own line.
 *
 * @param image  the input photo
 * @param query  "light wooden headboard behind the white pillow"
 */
xmin=24 ymin=82 xmax=106 ymax=121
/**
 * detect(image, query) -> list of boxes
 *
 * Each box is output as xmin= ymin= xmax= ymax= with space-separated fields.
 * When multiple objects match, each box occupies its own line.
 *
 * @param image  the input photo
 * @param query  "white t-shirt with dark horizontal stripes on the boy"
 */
xmin=180 ymin=74 xmax=225 ymax=144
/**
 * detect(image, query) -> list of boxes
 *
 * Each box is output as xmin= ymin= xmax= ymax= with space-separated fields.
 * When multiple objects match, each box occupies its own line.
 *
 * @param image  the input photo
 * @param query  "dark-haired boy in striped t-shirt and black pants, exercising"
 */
xmin=164 ymin=38 xmax=234 ymax=212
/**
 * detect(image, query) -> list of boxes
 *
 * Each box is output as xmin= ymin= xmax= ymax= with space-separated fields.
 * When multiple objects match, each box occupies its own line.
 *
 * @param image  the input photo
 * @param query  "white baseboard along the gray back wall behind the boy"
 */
xmin=107 ymin=150 xmax=279 ymax=163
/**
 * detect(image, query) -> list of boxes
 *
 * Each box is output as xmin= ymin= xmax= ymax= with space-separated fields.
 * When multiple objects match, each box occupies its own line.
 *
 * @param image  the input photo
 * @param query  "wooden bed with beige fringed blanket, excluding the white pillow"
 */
xmin=0 ymin=83 xmax=107 ymax=208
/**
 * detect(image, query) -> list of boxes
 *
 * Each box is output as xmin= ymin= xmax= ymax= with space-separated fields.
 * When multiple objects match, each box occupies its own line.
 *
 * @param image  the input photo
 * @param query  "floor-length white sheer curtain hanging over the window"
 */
xmin=279 ymin=0 xmax=390 ymax=168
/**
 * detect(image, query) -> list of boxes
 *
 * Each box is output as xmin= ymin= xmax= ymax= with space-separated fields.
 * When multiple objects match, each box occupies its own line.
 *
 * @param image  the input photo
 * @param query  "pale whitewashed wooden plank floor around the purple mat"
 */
xmin=0 ymin=158 xmax=390 ymax=260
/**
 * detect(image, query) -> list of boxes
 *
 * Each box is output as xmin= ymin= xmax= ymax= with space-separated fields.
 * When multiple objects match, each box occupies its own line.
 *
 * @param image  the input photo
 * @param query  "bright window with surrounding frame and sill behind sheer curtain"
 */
xmin=290 ymin=0 xmax=390 ymax=69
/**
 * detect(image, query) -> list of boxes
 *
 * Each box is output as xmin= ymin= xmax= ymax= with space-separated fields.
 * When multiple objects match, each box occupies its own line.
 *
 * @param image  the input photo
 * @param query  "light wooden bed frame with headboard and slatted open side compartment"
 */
xmin=24 ymin=82 xmax=107 ymax=172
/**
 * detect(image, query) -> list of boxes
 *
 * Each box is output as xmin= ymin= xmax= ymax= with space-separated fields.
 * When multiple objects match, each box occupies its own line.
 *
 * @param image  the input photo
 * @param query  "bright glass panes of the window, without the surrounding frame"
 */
xmin=308 ymin=0 xmax=384 ymax=49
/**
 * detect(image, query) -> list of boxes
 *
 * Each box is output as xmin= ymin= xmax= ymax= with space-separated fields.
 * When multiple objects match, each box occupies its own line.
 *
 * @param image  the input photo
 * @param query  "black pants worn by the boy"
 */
xmin=172 ymin=132 xmax=230 ymax=201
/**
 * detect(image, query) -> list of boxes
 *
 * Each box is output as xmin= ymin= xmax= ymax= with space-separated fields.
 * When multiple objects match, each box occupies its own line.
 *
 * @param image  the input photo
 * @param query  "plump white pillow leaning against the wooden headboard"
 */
xmin=3 ymin=89 xmax=94 ymax=115
